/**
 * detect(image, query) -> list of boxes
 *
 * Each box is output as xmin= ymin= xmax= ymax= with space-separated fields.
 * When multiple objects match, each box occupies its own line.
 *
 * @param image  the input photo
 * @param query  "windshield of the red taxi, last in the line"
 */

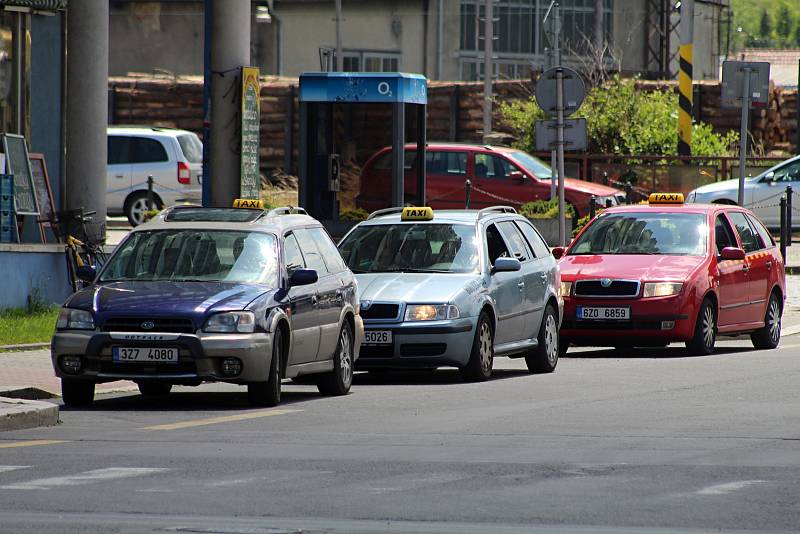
xmin=569 ymin=213 xmax=708 ymax=256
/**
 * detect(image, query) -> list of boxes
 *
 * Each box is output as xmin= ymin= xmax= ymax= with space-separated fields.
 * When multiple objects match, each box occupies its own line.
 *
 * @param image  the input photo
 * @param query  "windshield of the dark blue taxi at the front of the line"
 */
xmin=100 ymin=229 xmax=278 ymax=287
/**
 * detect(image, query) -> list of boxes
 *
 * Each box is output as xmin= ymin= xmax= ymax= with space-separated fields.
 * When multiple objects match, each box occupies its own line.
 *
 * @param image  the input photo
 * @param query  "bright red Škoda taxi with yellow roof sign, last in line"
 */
xmin=553 ymin=194 xmax=786 ymax=354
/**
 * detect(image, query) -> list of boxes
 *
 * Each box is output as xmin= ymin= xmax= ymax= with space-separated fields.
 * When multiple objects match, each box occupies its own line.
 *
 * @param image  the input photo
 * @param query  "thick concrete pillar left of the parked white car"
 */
xmin=64 ymin=0 xmax=108 ymax=241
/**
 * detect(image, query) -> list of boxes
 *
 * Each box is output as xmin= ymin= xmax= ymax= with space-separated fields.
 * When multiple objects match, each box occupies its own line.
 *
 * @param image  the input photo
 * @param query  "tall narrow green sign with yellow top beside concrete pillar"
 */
xmin=239 ymin=67 xmax=261 ymax=198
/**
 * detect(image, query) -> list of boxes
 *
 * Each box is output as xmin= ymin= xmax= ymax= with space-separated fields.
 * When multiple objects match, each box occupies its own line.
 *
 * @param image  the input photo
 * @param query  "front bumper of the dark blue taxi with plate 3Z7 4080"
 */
xmin=50 ymin=330 xmax=272 ymax=384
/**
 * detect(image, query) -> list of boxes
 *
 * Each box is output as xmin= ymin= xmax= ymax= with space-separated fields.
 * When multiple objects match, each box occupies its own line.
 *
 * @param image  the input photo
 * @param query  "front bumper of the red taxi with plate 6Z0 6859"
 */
xmin=560 ymin=294 xmax=697 ymax=346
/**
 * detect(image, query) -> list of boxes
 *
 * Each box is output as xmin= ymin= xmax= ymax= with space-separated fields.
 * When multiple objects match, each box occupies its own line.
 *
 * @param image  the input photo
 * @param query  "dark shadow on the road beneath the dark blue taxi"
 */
xmin=60 ymin=383 xmax=323 ymax=412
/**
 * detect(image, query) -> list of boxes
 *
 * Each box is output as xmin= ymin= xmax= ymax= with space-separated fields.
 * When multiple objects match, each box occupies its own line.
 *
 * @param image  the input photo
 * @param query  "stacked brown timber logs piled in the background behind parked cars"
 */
xmin=109 ymin=76 xmax=798 ymax=180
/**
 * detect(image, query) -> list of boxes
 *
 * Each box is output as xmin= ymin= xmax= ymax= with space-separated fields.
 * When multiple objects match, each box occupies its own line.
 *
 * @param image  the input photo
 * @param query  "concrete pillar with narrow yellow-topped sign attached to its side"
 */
xmin=211 ymin=0 xmax=250 ymax=207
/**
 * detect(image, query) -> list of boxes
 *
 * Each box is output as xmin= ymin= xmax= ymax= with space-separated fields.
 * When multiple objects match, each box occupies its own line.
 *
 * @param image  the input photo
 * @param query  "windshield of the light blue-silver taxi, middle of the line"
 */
xmin=339 ymin=223 xmax=478 ymax=273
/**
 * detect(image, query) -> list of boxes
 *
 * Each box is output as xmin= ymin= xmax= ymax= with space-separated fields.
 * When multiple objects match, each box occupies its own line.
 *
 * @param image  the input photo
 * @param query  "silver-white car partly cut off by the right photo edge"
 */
xmin=686 ymin=156 xmax=800 ymax=228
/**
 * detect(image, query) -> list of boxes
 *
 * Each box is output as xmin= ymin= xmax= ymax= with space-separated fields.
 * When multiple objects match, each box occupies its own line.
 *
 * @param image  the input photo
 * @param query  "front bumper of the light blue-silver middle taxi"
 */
xmin=356 ymin=317 xmax=478 ymax=369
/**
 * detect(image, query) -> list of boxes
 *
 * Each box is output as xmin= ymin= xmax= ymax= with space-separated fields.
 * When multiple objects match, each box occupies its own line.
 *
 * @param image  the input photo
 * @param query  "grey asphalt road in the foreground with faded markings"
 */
xmin=0 ymin=337 xmax=800 ymax=533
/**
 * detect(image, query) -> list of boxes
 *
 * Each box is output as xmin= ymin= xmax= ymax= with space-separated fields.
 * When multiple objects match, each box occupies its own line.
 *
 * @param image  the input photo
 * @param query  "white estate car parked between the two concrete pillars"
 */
xmin=106 ymin=126 xmax=203 ymax=226
